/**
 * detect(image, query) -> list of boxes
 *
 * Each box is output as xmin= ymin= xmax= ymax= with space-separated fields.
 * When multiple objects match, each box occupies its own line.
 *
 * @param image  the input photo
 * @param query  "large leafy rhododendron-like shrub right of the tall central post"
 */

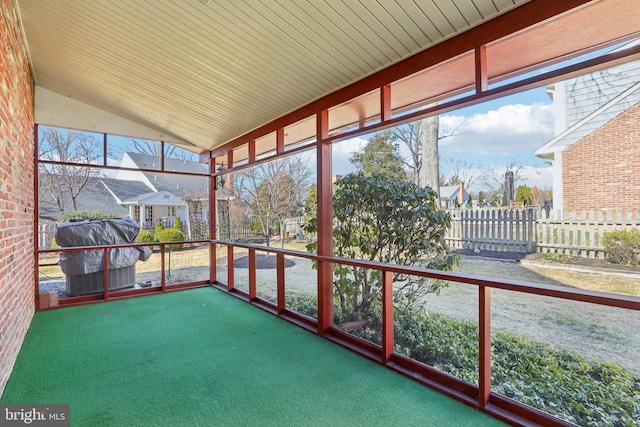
xmin=305 ymin=172 xmax=458 ymax=322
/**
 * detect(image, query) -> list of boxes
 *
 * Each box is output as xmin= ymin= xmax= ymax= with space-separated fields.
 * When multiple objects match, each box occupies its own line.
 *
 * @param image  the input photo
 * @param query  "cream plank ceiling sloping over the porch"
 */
xmin=15 ymin=0 xmax=526 ymax=151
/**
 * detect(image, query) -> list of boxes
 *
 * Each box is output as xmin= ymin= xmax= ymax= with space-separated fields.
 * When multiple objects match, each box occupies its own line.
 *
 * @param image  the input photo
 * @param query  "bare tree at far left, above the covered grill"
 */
xmin=38 ymin=128 xmax=103 ymax=213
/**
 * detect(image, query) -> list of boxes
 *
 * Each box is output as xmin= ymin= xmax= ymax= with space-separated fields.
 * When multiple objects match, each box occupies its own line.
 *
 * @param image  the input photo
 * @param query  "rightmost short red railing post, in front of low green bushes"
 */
xmin=478 ymin=286 xmax=491 ymax=408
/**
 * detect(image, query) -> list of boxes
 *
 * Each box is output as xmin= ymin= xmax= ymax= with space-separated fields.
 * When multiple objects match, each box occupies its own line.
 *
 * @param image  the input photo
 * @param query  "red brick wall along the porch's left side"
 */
xmin=0 ymin=0 xmax=35 ymax=395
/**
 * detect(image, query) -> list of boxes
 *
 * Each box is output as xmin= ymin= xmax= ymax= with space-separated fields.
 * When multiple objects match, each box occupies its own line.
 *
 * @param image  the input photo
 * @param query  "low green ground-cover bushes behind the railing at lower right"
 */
xmin=395 ymin=314 xmax=640 ymax=426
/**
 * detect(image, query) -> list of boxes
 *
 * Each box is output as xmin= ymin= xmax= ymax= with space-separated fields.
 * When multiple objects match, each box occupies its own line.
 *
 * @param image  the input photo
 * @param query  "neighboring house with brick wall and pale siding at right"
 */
xmin=535 ymin=41 xmax=640 ymax=210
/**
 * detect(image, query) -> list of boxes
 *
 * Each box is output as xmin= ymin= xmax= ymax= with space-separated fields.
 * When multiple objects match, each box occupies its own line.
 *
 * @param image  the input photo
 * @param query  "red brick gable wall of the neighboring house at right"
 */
xmin=562 ymin=103 xmax=640 ymax=210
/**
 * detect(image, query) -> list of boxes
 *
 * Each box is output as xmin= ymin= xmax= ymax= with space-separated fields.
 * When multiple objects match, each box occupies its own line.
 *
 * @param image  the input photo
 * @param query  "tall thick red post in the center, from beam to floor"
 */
xmin=316 ymin=110 xmax=333 ymax=335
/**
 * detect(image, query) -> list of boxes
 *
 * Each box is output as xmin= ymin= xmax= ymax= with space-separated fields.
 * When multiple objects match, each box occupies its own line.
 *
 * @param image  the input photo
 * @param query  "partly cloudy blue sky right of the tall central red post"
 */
xmin=334 ymin=87 xmax=554 ymax=191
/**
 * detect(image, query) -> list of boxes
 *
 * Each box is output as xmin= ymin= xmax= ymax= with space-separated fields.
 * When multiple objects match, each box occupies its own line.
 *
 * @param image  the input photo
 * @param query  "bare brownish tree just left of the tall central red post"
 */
xmin=234 ymin=156 xmax=311 ymax=246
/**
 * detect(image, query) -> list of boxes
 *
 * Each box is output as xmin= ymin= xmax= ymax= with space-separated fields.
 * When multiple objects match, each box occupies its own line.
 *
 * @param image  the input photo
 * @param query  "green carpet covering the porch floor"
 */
xmin=0 ymin=288 xmax=502 ymax=427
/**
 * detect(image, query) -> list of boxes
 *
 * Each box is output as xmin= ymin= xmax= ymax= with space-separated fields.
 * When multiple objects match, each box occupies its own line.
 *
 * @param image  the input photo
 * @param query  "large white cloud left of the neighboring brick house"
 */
xmin=440 ymin=103 xmax=553 ymax=155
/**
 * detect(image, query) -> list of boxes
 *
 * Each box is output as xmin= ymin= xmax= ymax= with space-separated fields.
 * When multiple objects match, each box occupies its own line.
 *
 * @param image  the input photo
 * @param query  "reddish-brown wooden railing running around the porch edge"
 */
xmin=36 ymin=240 xmax=640 ymax=426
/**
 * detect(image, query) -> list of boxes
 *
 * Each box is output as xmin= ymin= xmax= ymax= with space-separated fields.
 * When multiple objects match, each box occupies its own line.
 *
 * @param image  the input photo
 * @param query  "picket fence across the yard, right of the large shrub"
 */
xmin=445 ymin=207 xmax=640 ymax=258
